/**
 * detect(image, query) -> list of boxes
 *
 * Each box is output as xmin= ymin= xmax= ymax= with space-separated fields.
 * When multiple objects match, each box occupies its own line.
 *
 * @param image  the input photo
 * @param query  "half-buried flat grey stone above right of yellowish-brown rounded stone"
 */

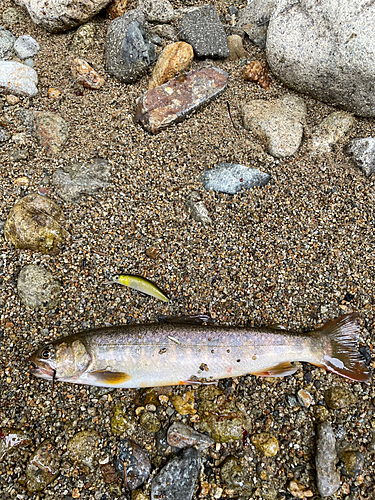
xmin=52 ymin=158 xmax=111 ymax=202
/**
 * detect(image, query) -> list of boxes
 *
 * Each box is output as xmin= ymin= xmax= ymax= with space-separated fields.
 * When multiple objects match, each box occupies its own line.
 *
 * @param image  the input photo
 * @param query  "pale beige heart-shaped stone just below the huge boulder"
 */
xmin=242 ymin=95 xmax=306 ymax=158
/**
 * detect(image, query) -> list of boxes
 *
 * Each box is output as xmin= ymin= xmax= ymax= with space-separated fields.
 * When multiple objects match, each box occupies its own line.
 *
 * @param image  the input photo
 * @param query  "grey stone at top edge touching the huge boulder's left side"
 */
xmin=237 ymin=0 xmax=277 ymax=49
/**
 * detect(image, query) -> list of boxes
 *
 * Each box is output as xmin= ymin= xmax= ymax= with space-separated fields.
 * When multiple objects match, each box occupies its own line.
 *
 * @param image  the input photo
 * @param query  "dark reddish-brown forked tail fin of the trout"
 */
xmin=316 ymin=313 xmax=371 ymax=382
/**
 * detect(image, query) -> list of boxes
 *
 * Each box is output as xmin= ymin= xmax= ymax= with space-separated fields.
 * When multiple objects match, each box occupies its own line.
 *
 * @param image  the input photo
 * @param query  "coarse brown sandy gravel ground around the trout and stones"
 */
xmin=0 ymin=0 xmax=375 ymax=500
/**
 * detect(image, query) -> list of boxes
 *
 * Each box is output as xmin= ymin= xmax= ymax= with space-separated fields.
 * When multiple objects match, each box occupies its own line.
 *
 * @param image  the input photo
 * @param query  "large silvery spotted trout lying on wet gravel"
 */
xmin=29 ymin=313 xmax=371 ymax=388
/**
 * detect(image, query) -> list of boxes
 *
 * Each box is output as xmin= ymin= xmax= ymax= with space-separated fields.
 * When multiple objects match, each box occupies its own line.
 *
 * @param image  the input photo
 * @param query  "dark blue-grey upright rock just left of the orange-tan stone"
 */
xmin=105 ymin=10 xmax=155 ymax=83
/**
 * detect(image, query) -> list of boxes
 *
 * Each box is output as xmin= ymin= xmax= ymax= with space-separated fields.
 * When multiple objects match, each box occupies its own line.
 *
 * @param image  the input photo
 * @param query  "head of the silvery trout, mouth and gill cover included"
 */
xmin=28 ymin=336 xmax=91 ymax=381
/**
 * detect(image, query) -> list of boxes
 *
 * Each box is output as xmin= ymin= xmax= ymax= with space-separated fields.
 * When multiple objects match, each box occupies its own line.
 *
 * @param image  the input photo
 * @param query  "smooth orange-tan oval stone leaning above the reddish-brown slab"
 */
xmin=148 ymin=42 xmax=194 ymax=89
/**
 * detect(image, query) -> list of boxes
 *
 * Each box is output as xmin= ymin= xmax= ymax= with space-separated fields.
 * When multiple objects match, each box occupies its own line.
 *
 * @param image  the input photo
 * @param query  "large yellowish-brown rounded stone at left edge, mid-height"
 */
xmin=4 ymin=193 xmax=69 ymax=254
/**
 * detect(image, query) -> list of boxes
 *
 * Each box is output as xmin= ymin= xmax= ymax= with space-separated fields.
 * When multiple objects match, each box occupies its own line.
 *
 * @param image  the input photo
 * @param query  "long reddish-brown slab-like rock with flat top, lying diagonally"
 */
xmin=135 ymin=68 xmax=228 ymax=134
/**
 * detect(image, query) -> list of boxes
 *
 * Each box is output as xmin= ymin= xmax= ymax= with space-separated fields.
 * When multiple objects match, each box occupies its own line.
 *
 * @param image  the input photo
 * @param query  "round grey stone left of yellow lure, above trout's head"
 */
xmin=17 ymin=264 xmax=61 ymax=309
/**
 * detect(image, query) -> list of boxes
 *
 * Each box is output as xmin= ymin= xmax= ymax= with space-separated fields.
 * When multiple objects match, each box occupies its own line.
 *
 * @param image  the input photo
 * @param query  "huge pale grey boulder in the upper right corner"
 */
xmin=267 ymin=0 xmax=375 ymax=117
